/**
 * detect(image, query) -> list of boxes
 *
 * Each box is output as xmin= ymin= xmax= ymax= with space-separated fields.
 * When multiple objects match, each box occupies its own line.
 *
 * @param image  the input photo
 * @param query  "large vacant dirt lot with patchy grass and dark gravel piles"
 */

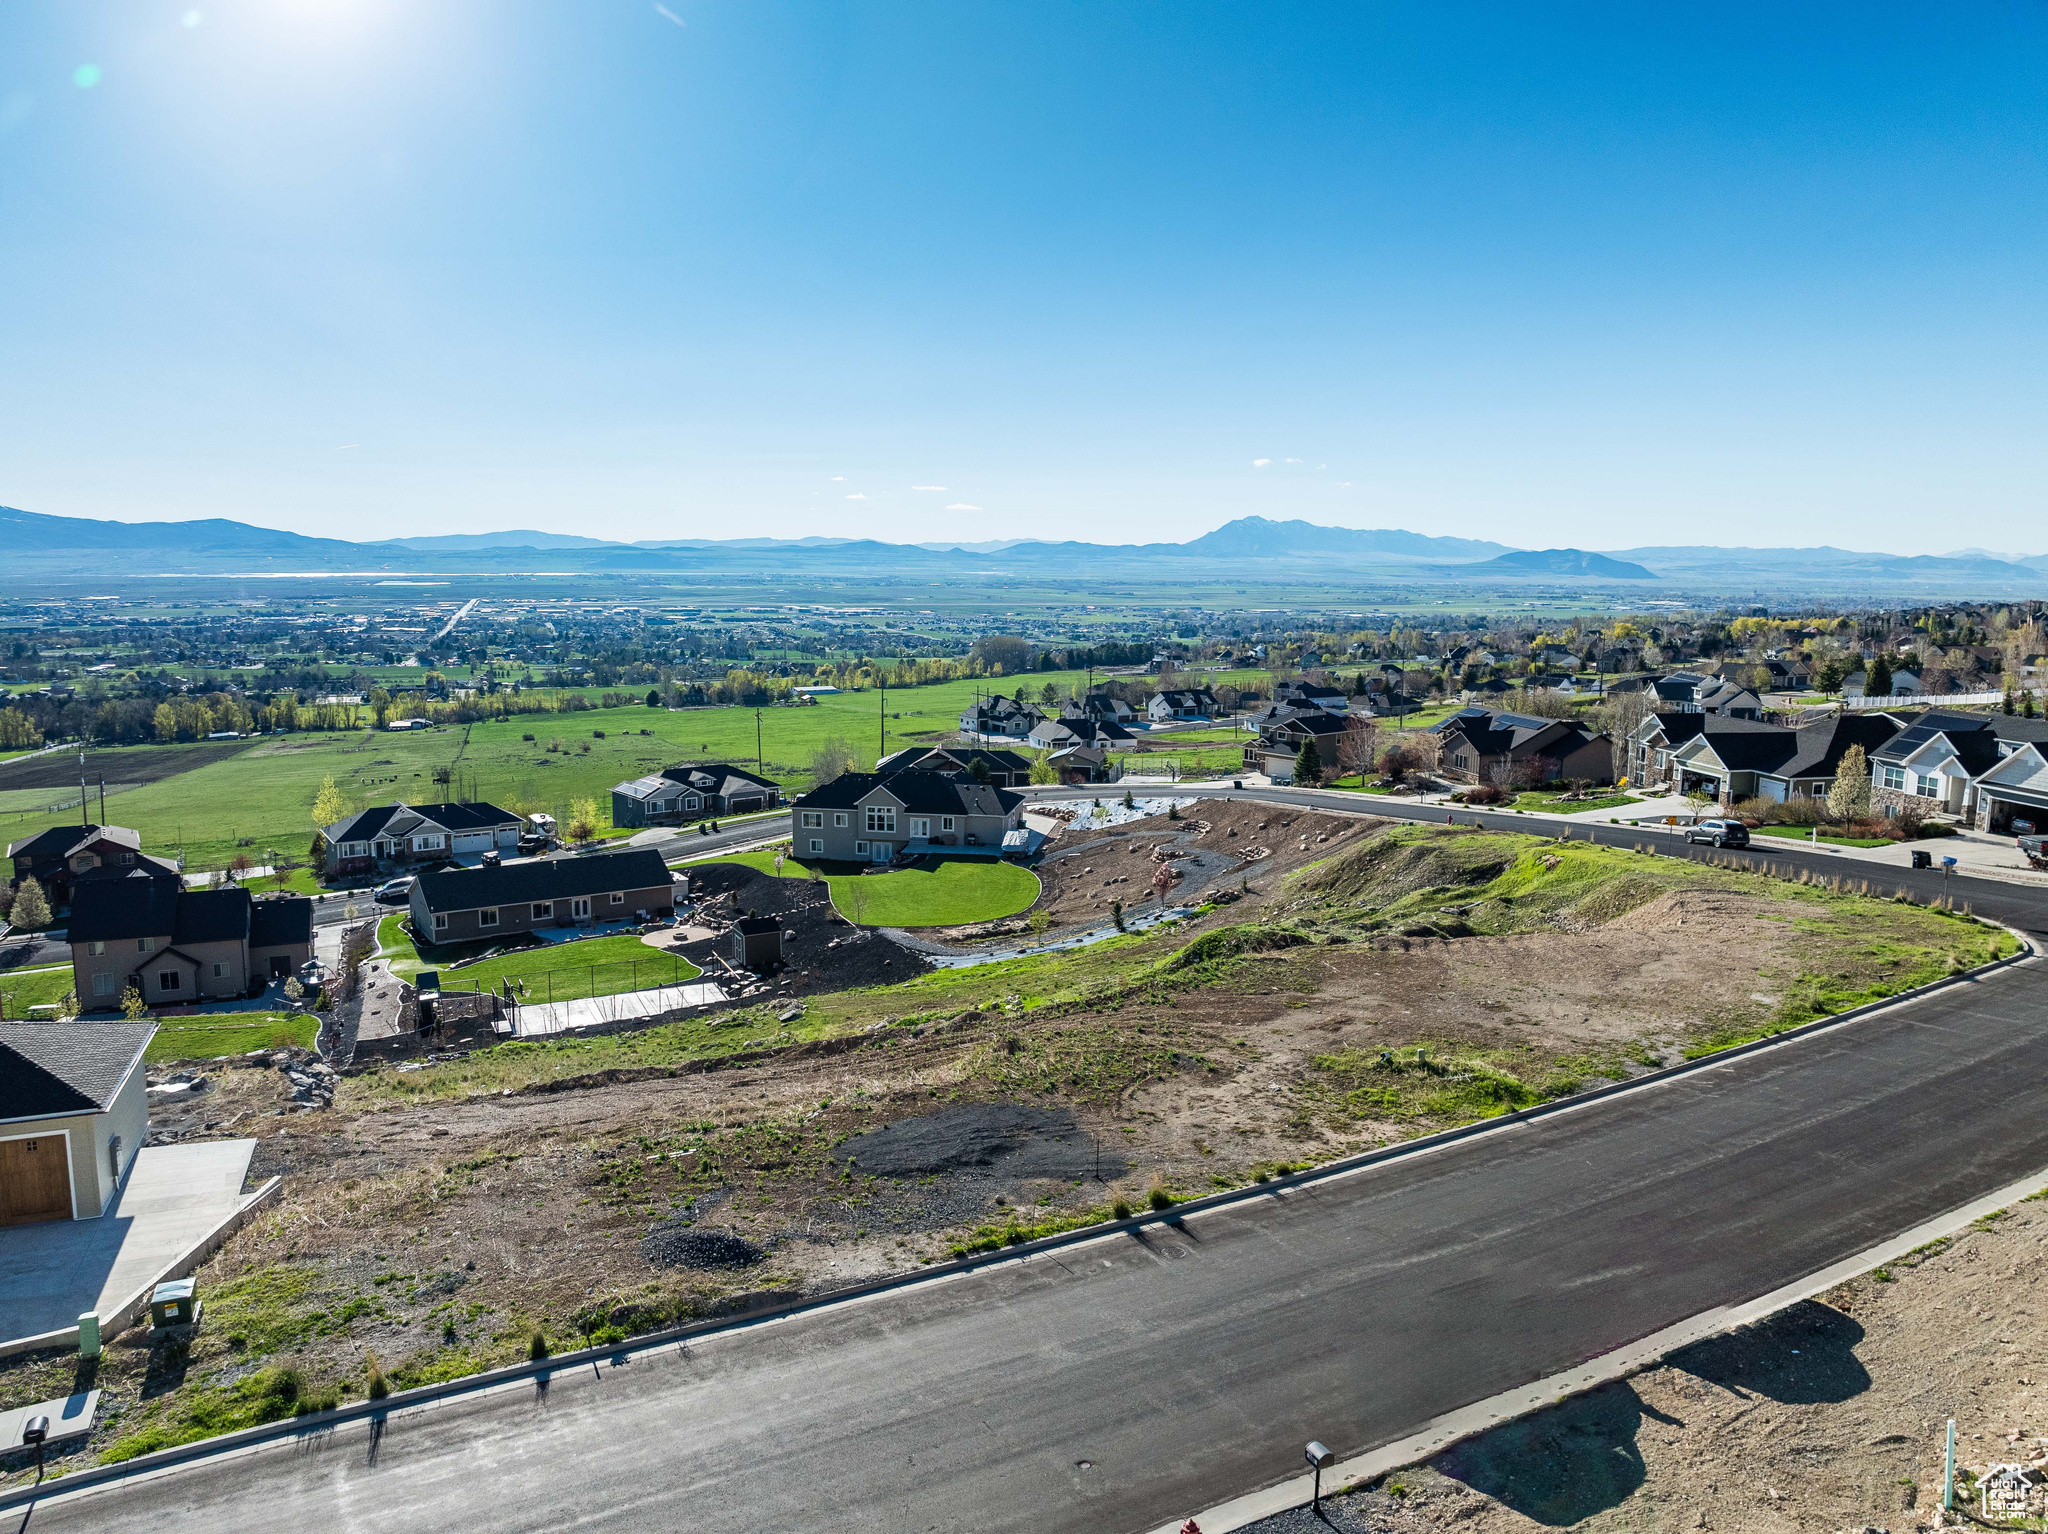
xmin=0 ymin=831 xmax=2015 ymax=1474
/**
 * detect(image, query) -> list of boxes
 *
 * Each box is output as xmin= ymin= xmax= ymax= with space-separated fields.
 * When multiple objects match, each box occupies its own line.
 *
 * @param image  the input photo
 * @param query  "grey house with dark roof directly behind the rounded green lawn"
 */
xmin=791 ymin=768 xmax=1024 ymax=862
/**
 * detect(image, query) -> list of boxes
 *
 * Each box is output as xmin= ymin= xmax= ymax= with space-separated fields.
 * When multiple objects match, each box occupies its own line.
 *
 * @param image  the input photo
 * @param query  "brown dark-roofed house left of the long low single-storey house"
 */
xmin=68 ymin=858 xmax=313 ymax=1012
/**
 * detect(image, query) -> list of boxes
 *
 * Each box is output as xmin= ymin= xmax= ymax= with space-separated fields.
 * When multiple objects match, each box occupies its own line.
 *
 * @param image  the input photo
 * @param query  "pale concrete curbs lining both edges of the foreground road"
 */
xmin=0 ymin=909 xmax=2038 ymax=1528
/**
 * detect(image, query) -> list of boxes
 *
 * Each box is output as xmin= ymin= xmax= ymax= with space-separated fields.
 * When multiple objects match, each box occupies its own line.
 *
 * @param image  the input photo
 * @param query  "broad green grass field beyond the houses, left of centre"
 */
xmin=0 ymin=672 xmax=1085 ymax=868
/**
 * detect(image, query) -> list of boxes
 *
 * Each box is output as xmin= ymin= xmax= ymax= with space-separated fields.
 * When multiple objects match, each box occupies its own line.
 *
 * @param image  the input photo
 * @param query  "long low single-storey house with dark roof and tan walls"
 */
xmin=412 ymin=848 xmax=676 ymax=944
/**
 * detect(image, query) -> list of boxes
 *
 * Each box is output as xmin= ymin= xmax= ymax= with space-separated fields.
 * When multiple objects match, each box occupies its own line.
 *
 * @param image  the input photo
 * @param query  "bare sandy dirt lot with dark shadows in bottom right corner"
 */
xmin=1255 ymin=1200 xmax=2048 ymax=1534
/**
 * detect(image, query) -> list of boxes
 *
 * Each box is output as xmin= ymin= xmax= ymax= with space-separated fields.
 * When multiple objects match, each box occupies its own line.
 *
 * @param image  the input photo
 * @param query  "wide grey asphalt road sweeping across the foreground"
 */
xmin=33 ymin=795 xmax=2048 ymax=1534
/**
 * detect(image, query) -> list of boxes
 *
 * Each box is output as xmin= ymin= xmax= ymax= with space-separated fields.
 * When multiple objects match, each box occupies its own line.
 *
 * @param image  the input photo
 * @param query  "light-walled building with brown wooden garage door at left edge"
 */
xmin=0 ymin=1022 xmax=156 ymax=1225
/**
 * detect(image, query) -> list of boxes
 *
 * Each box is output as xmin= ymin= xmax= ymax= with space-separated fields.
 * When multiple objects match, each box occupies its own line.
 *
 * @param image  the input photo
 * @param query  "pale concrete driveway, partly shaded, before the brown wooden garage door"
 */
xmin=0 ymin=1141 xmax=256 ymax=1344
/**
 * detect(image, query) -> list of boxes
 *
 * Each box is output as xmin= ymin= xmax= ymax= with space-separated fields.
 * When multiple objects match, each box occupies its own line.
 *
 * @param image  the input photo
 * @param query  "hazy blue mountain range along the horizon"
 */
xmin=0 ymin=508 xmax=2048 ymax=600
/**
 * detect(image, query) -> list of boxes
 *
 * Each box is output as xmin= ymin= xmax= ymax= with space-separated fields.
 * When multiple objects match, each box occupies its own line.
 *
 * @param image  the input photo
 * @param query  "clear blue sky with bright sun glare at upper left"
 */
xmin=0 ymin=0 xmax=2048 ymax=553
